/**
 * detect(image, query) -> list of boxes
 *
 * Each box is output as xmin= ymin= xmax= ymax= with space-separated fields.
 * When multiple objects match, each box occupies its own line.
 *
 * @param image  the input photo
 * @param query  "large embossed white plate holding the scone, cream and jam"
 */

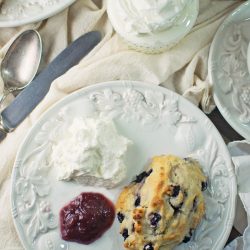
xmin=11 ymin=81 xmax=236 ymax=250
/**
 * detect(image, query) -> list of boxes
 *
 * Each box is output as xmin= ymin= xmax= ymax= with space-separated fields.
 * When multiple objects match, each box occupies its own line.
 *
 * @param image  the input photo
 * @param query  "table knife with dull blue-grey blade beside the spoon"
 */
xmin=0 ymin=31 xmax=101 ymax=142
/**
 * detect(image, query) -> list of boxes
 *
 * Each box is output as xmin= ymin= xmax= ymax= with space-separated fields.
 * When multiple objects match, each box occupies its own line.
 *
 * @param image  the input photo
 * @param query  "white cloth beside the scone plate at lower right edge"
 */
xmin=224 ymin=140 xmax=250 ymax=250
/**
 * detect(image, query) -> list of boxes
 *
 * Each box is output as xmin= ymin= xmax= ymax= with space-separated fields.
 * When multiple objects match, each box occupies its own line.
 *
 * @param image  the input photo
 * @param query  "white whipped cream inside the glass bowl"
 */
xmin=119 ymin=0 xmax=190 ymax=34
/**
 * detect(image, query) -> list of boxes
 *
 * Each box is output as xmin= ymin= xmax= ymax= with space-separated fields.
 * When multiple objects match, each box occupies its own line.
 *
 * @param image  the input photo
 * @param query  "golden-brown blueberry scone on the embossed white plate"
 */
xmin=116 ymin=155 xmax=207 ymax=250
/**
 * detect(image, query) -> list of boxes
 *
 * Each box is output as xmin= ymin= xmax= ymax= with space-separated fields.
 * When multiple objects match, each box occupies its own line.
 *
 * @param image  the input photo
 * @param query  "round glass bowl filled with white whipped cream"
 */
xmin=107 ymin=0 xmax=199 ymax=53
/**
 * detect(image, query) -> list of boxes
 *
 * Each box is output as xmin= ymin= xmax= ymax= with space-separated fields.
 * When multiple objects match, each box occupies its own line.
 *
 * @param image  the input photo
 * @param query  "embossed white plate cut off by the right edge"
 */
xmin=208 ymin=1 xmax=250 ymax=140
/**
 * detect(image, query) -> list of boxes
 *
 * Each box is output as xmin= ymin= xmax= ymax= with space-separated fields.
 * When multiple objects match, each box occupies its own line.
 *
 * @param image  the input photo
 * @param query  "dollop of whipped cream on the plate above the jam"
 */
xmin=51 ymin=117 xmax=132 ymax=188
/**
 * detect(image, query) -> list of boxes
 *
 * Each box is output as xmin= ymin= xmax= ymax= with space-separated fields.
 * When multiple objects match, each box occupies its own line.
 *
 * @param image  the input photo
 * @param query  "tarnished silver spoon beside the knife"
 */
xmin=0 ymin=30 xmax=42 ymax=106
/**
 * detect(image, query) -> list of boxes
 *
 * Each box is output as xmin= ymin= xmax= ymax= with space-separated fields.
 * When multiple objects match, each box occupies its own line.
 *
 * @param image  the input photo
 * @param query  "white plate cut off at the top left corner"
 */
xmin=0 ymin=0 xmax=75 ymax=27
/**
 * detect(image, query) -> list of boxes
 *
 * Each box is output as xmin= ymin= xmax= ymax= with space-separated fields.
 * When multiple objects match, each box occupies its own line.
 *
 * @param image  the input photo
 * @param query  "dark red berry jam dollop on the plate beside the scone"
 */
xmin=60 ymin=192 xmax=115 ymax=244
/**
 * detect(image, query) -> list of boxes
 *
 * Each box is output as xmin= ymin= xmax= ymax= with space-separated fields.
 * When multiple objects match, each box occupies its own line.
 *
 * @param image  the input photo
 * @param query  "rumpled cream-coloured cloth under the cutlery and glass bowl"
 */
xmin=0 ymin=0 xmax=244 ymax=250
